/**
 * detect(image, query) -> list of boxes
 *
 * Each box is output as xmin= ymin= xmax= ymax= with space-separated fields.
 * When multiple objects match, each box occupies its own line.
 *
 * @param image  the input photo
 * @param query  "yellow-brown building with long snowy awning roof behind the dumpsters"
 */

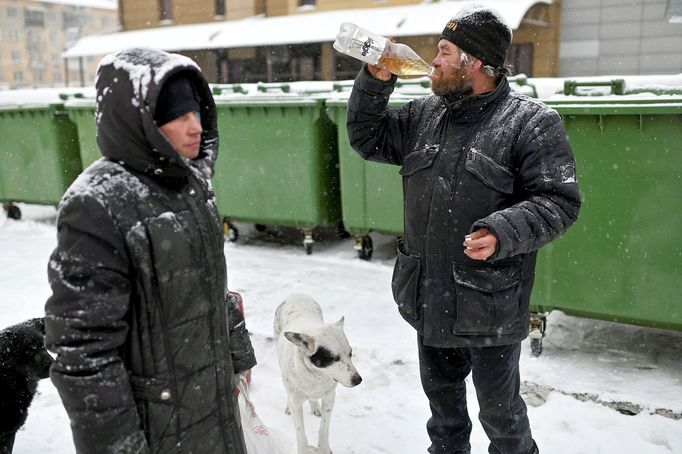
xmin=65 ymin=0 xmax=561 ymax=84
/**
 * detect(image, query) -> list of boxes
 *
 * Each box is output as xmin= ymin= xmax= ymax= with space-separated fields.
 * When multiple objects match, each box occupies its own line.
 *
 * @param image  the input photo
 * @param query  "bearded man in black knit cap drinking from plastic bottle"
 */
xmin=347 ymin=6 xmax=581 ymax=454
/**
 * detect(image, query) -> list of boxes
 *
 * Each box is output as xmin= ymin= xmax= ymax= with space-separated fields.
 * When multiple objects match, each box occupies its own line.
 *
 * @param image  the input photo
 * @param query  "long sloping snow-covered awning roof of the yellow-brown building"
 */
xmin=62 ymin=0 xmax=552 ymax=57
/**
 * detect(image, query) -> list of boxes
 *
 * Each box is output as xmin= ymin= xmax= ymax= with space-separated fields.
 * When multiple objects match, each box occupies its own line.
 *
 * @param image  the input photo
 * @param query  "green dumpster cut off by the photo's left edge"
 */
xmin=0 ymin=103 xmax=82 ymax=219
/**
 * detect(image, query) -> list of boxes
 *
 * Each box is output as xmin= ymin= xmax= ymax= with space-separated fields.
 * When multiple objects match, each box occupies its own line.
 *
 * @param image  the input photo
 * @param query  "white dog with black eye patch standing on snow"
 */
xmin=274 ymin=294 xmax=362 ymax=454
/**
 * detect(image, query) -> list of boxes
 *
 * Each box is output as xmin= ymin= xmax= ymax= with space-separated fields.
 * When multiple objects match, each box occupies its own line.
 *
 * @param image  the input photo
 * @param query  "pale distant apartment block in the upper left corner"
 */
xmin=0 ymin=0 xmax=118 ymax=88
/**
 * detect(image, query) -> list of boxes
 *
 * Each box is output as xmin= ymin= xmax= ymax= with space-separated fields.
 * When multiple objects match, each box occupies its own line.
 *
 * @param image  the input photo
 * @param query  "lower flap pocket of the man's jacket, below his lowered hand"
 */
xmin=453 ymin=264 xmax=521 ymax=335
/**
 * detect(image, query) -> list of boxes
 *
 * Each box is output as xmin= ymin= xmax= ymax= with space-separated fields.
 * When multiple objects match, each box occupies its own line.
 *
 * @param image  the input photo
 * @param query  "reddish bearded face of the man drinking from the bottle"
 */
xmin=431 ymin=39 xmax=473 ymax=96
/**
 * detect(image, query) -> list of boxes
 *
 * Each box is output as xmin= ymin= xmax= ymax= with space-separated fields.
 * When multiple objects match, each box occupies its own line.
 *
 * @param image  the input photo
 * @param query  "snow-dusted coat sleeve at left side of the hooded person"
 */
xmin=45 ymin=193 xmax=148 ymax=454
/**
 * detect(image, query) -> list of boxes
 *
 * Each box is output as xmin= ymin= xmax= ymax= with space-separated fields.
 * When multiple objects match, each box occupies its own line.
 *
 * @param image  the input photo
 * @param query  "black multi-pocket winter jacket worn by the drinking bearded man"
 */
xmin=348 ymin=68 xmax=580 ymax=347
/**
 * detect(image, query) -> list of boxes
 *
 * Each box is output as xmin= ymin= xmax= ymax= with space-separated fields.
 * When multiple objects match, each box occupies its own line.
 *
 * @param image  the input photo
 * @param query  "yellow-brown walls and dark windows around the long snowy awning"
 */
xmin=110 ymin=0 xmax=561 ymax=83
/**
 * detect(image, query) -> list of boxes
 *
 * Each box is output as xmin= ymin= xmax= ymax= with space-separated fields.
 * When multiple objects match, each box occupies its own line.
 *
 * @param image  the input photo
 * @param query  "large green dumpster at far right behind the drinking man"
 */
xmin=531 ymin=84 xmax=682 ymax=355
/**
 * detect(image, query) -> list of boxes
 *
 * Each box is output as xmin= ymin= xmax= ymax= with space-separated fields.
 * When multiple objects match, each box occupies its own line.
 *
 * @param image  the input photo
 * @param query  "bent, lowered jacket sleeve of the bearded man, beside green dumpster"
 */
xmin=472 ymin=107 xmax=581 ymax=260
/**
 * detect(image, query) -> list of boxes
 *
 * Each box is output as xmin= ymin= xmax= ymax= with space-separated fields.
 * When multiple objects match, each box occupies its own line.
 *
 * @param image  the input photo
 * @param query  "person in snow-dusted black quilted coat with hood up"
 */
xmin=45 ymin=49 xmax=255 ymax=454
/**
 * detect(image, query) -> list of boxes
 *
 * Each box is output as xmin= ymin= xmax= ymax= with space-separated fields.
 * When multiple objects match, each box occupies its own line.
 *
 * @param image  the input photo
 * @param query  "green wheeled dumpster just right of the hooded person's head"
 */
xmin=213 ymin=84 xmax=341 ymax=254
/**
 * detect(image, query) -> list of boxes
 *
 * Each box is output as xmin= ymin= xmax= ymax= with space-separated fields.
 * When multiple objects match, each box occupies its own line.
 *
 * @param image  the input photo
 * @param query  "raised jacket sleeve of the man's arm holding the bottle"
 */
xmin=346 ymin=65 xmax=409 ymax=165
